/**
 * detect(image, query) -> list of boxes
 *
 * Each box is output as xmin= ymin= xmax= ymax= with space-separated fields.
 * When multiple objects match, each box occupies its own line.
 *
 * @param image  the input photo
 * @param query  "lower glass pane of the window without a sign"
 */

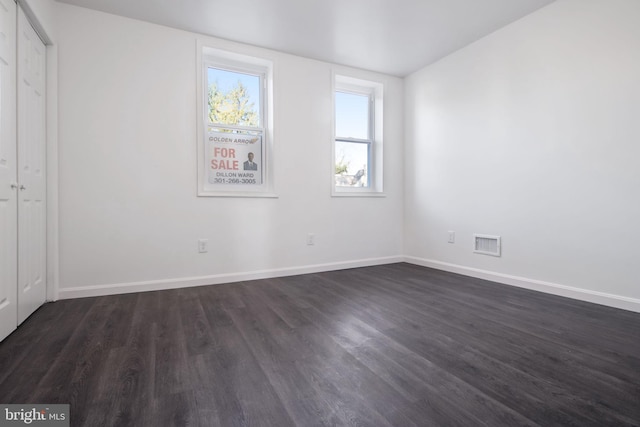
xmin=335 ymin=141 xmax=369 ymax=187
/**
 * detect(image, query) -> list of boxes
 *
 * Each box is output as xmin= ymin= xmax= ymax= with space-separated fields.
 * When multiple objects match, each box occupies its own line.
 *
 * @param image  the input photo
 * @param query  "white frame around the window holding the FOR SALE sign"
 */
xmin=197 ymin=42 xmax=277 ymax=197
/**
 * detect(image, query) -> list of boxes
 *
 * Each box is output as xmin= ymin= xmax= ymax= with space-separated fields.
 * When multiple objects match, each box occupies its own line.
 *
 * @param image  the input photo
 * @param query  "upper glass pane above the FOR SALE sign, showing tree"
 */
xmin=207 ymin=67 xmax=261 ymax=127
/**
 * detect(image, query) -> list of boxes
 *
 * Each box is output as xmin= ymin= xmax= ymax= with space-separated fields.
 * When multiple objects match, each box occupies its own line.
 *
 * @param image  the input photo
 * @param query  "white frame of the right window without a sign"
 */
xmin=331 ymin=73 xmax=385 ymax=197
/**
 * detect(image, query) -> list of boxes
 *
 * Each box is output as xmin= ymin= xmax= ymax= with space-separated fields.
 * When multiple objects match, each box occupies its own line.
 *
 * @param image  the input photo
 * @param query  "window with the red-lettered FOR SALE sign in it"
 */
xmin=198 ymin=47 xmax=273 ymax=197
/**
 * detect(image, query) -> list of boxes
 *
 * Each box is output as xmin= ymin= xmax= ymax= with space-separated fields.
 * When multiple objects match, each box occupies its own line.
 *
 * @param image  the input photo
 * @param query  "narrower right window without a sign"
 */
xmin=333 ymin=75 xmax=382 ymax=195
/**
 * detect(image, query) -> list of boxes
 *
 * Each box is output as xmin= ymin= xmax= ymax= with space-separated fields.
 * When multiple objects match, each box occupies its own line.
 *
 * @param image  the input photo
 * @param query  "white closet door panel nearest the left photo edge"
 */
xmin=0 ymin=0 xmax=18 ymax=340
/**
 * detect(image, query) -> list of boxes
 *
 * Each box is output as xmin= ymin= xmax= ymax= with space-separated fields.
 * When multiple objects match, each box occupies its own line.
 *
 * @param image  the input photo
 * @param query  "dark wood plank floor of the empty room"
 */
xmin=0 ymin=264 xmax=640 ymax=427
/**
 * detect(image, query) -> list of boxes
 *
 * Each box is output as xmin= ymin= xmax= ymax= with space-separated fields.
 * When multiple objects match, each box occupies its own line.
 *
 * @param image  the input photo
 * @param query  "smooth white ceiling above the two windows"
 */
xmin=58 ymin=0 xmax=554 ymax=76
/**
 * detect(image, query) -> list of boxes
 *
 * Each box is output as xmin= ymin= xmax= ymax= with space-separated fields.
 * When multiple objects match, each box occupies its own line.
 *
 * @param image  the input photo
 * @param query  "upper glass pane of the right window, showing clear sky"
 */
xmin=336 ymin=92 xmax=369 ymax=139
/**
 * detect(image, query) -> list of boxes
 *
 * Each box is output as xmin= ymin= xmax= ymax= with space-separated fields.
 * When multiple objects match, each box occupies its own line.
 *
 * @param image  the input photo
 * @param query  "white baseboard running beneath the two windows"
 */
xmin=58 ymin=256 xmax=404 ymax=299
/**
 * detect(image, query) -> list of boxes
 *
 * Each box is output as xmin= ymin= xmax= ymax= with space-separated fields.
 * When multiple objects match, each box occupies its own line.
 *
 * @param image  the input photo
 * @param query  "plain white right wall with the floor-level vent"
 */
xmin=405 ymin=0 xmax=640 ymax=311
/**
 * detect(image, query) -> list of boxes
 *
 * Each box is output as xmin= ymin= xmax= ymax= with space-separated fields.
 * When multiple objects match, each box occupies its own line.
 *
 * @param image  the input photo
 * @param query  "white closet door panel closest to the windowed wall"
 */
xmin=17 ymin=8 xmax=47 ymax=324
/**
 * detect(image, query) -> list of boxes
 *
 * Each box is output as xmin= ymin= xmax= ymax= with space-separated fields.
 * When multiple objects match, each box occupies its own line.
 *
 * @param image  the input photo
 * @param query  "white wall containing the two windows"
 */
xmin=58 ymin=4 xmax=404 ymax=298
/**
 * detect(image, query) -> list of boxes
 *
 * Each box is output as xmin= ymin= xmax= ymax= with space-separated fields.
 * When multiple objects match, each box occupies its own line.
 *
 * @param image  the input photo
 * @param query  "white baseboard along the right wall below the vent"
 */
xmin=404 ymin=256 xmax=640 ymax=313
